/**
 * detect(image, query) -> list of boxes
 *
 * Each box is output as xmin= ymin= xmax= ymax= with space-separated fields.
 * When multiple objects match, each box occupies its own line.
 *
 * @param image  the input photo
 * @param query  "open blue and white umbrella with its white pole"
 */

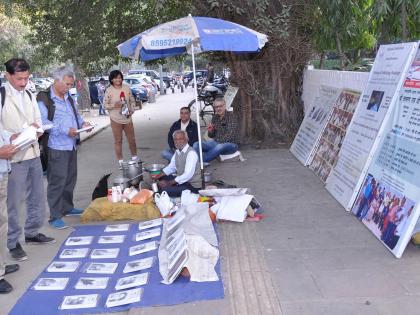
xmin=118 ymin=15 xmax=268 ymax=186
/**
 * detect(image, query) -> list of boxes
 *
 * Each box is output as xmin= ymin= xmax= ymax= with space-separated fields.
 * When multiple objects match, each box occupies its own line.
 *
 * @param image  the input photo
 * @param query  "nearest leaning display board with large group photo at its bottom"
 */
xmin=351 ymin=50 xmax=420 ymax=257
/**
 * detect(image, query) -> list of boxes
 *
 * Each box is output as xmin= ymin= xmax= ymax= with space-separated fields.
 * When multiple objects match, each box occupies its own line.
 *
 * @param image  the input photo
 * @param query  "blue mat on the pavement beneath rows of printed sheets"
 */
xmin=9 ymin=223 xmax=224 ymax=315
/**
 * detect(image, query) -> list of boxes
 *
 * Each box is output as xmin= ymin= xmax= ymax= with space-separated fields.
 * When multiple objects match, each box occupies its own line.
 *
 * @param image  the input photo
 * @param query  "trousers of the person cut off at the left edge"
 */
xmin=0 ymin=173 xmax=7 ymax=280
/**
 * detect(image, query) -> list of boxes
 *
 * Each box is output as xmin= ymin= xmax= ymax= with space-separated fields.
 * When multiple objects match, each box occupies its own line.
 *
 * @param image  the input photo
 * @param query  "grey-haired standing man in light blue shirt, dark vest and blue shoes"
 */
xmin=37 ymin=67 xmax=90 ymax=229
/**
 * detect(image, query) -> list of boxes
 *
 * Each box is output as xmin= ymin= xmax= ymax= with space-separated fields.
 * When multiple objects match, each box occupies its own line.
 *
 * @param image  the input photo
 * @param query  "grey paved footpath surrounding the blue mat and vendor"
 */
xmin=0 ymin=89 xmax=420 ymax=315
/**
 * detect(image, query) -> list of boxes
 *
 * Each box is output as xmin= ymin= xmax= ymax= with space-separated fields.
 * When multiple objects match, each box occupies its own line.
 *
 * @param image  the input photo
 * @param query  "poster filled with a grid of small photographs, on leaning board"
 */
xmin=309 ymin=89 xmax=360 ymax=182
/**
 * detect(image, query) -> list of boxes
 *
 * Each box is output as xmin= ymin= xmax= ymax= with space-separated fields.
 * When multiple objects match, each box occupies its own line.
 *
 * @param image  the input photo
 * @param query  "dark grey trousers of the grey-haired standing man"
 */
xmin=47 ymin=148 xmax=77 ymax=221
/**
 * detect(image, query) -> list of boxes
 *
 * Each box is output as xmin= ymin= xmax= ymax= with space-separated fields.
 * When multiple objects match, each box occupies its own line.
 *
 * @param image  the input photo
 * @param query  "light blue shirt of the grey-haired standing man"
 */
xmin=38 ymin=87 xmax=84 ymax=151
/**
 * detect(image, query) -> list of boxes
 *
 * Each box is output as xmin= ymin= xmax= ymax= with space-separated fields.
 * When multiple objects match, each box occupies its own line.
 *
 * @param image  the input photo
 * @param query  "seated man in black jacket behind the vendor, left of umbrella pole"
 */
xmin=160 ymin=107 xmax=198 ymax=161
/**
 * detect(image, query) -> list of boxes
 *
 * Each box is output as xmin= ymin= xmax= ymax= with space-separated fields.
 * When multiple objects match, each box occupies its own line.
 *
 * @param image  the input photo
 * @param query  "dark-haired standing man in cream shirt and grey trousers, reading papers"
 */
xmin=0 ymin=58 xmax=55 ymax=260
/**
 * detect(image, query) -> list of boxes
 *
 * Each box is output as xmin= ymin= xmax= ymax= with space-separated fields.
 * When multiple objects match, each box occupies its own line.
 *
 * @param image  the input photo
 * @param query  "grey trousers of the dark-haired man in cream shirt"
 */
xmin=7 ymin=157 xmax=45 ymax=249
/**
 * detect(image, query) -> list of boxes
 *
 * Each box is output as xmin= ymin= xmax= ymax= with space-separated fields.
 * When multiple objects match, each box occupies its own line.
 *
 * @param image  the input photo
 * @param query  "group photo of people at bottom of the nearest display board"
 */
xmin=352 ymin=174 xmax=415 ymax=250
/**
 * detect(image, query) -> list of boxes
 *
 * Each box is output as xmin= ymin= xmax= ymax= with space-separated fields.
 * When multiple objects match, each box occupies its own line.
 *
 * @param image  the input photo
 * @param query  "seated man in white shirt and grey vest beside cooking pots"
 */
xmin=151 ymin=130 xmax=199 ymax=197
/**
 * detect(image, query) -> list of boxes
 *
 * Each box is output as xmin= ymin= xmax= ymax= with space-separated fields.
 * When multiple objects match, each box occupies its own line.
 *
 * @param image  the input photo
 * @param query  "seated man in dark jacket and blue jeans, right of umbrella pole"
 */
xmin=194 ymin=98 xmax=239 ymax=163
